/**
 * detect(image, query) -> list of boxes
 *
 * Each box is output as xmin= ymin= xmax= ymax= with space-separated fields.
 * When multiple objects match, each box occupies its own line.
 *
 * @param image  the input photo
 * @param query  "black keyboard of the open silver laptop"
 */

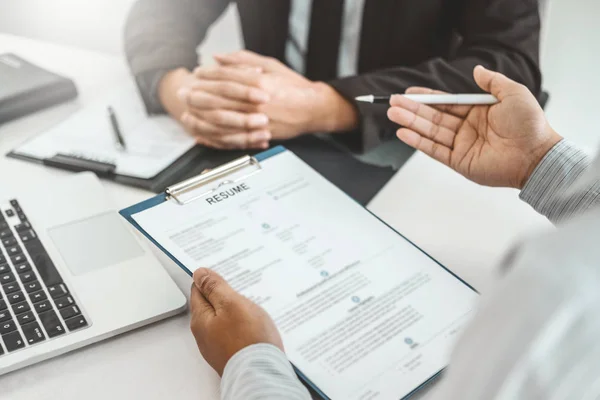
xmin=0 ymin=200 xmax=88 ymax=357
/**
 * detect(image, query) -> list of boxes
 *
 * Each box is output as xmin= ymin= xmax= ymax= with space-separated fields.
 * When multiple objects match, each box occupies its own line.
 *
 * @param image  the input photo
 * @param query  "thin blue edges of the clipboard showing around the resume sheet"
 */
xmin=119 ymin=146 xmax=479 ymax=400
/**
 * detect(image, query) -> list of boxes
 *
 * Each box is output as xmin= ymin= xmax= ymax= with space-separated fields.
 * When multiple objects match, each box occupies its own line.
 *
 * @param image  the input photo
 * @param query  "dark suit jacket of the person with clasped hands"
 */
xmin=125 ymin=0 xmax=541 ymax=151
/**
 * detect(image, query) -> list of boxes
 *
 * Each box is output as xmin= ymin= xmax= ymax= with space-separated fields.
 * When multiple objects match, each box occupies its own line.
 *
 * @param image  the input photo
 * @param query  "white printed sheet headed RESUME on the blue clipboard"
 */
xmin=132 ymin=151 xmax=477 ymax=400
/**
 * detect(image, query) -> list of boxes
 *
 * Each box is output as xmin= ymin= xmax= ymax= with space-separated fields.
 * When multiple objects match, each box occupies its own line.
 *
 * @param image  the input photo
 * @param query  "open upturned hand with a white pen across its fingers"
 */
xmin=388 ymin=67 xmax=561 ymax=188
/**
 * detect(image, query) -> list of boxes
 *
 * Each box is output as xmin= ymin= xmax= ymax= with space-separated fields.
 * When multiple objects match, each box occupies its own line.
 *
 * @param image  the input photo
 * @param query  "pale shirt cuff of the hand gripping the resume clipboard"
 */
xmin=221 ymin=343 xmax=311 ymax=400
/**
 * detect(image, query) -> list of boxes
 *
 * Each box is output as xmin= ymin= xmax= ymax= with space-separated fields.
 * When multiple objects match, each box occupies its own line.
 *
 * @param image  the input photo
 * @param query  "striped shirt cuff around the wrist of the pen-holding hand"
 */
xmin=519 ymin=140 xmax=591 ymax=223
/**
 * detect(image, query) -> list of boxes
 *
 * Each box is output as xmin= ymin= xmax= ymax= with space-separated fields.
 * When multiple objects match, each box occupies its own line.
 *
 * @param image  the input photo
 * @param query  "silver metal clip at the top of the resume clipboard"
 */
xmin=165 ymin=156 xmax=262 ymax=206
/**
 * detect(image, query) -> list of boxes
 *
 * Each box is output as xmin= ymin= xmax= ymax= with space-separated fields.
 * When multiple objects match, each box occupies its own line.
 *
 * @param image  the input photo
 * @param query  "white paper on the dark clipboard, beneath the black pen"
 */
xmin=12 ymin=81 xmax=196 ymax=180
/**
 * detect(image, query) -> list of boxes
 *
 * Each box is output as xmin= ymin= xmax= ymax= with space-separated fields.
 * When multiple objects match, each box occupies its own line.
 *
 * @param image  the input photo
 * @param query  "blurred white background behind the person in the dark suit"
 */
xmin=0 ymin=0 xmax=600 ymax=147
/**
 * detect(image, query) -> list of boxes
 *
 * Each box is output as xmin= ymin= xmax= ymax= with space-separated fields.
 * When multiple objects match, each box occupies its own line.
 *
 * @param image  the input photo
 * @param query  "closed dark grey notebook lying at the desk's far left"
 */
xmin=0 ymin=53 xmax=77 ymax=124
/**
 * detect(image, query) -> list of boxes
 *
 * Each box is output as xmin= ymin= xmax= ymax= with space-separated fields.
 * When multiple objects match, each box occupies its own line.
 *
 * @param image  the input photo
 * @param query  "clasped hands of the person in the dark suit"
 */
xmin=171 ymin=51 xmax=356 ymax=149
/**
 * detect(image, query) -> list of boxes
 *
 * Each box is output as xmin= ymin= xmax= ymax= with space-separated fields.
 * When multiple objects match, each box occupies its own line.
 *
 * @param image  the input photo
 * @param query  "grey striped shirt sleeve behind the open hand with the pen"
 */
xmin=520 ymin=140 xmax=600 ymax=224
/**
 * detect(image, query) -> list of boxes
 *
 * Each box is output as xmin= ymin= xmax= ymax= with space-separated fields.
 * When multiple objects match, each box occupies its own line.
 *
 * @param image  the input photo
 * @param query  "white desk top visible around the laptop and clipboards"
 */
xmin=0 ymin=34 xmax=550 ymax=400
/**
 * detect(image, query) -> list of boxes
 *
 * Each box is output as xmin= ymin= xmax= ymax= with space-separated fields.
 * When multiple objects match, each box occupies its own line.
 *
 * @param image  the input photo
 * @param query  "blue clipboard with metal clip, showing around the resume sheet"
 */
xmin=120 ymin=146 xmax=477 ymax=399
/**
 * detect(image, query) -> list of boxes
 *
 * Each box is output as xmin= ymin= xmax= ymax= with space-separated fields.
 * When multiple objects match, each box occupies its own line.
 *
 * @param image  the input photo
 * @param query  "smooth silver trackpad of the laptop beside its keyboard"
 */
xmin=48 ymin=211 xmax=144 ymax=275
